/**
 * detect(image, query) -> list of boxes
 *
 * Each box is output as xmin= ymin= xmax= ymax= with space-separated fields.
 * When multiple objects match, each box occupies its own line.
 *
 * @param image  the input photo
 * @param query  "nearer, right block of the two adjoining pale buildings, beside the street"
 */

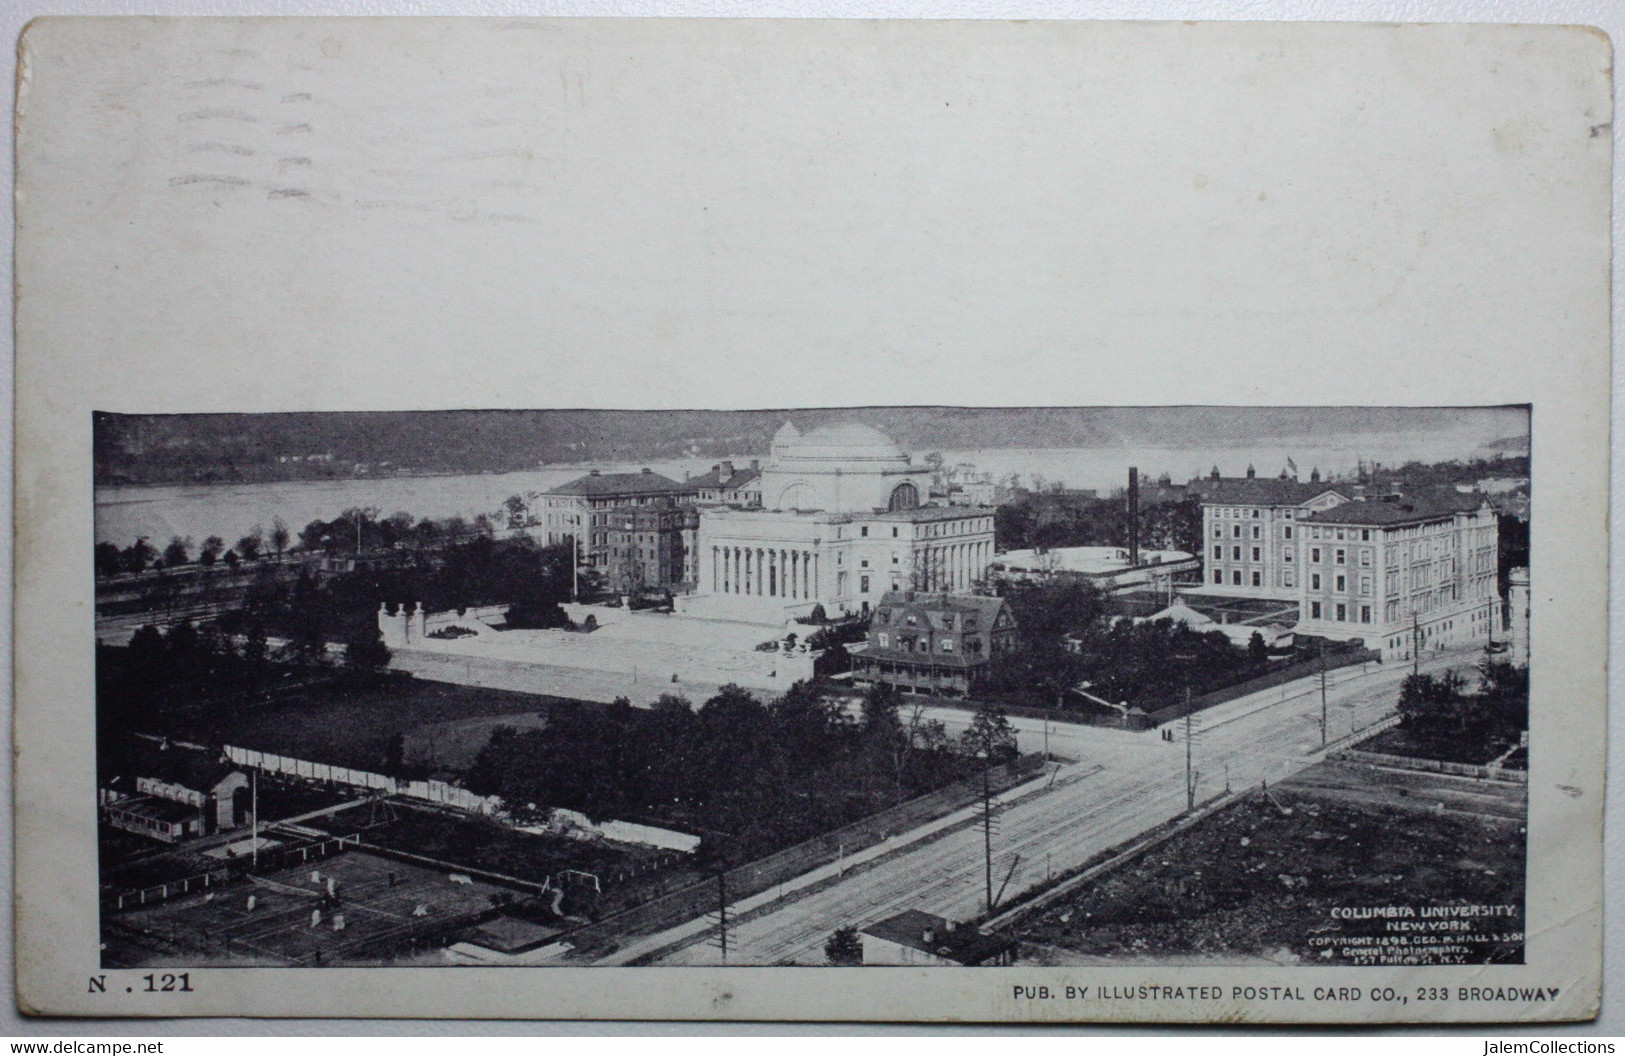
xmin=1298 ymin=492 xmax=1502 ymax=660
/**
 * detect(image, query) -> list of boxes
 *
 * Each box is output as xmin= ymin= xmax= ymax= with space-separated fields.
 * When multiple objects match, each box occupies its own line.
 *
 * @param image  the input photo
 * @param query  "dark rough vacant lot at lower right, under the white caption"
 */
xmin=1014 ymin=793 xmax=1524 ymax=965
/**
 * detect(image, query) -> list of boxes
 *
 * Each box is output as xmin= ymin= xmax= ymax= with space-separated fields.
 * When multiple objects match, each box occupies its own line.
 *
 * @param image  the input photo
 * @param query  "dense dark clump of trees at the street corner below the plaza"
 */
xmin=466 ymin=682 xmax=1016 ymax=859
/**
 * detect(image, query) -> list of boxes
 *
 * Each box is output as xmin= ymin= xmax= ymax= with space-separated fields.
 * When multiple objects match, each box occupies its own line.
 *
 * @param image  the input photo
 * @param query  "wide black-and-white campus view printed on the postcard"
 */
xmin=96 ymin=406 xmax=1539 ymax=978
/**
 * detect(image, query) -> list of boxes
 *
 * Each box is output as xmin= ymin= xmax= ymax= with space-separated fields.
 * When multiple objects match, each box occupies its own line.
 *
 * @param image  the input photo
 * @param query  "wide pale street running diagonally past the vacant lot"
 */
xmin=648 ymin=648 xmax=1482 ymax=965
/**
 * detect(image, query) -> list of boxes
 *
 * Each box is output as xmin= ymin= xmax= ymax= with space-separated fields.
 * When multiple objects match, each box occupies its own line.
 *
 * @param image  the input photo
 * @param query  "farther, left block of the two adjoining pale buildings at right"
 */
xmin=1191 ymin=470 xmax=1349 ymax=601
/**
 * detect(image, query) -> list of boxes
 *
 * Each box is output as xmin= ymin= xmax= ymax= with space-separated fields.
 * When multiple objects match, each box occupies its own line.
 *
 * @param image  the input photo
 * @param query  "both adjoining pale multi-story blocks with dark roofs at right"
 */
xmin=1191 ymin=471 xmax=1500 ymax=660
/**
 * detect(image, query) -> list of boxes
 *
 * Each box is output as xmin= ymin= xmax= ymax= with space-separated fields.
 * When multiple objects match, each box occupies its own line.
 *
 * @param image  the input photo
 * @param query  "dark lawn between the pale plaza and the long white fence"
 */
xmin=185 ymin=677 xmax=554 ymax=773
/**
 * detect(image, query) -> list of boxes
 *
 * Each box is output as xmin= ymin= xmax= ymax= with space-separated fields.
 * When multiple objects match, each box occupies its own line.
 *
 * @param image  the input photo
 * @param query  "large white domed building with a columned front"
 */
xmin=678 ymin=422 xmax=993 ymax=625
